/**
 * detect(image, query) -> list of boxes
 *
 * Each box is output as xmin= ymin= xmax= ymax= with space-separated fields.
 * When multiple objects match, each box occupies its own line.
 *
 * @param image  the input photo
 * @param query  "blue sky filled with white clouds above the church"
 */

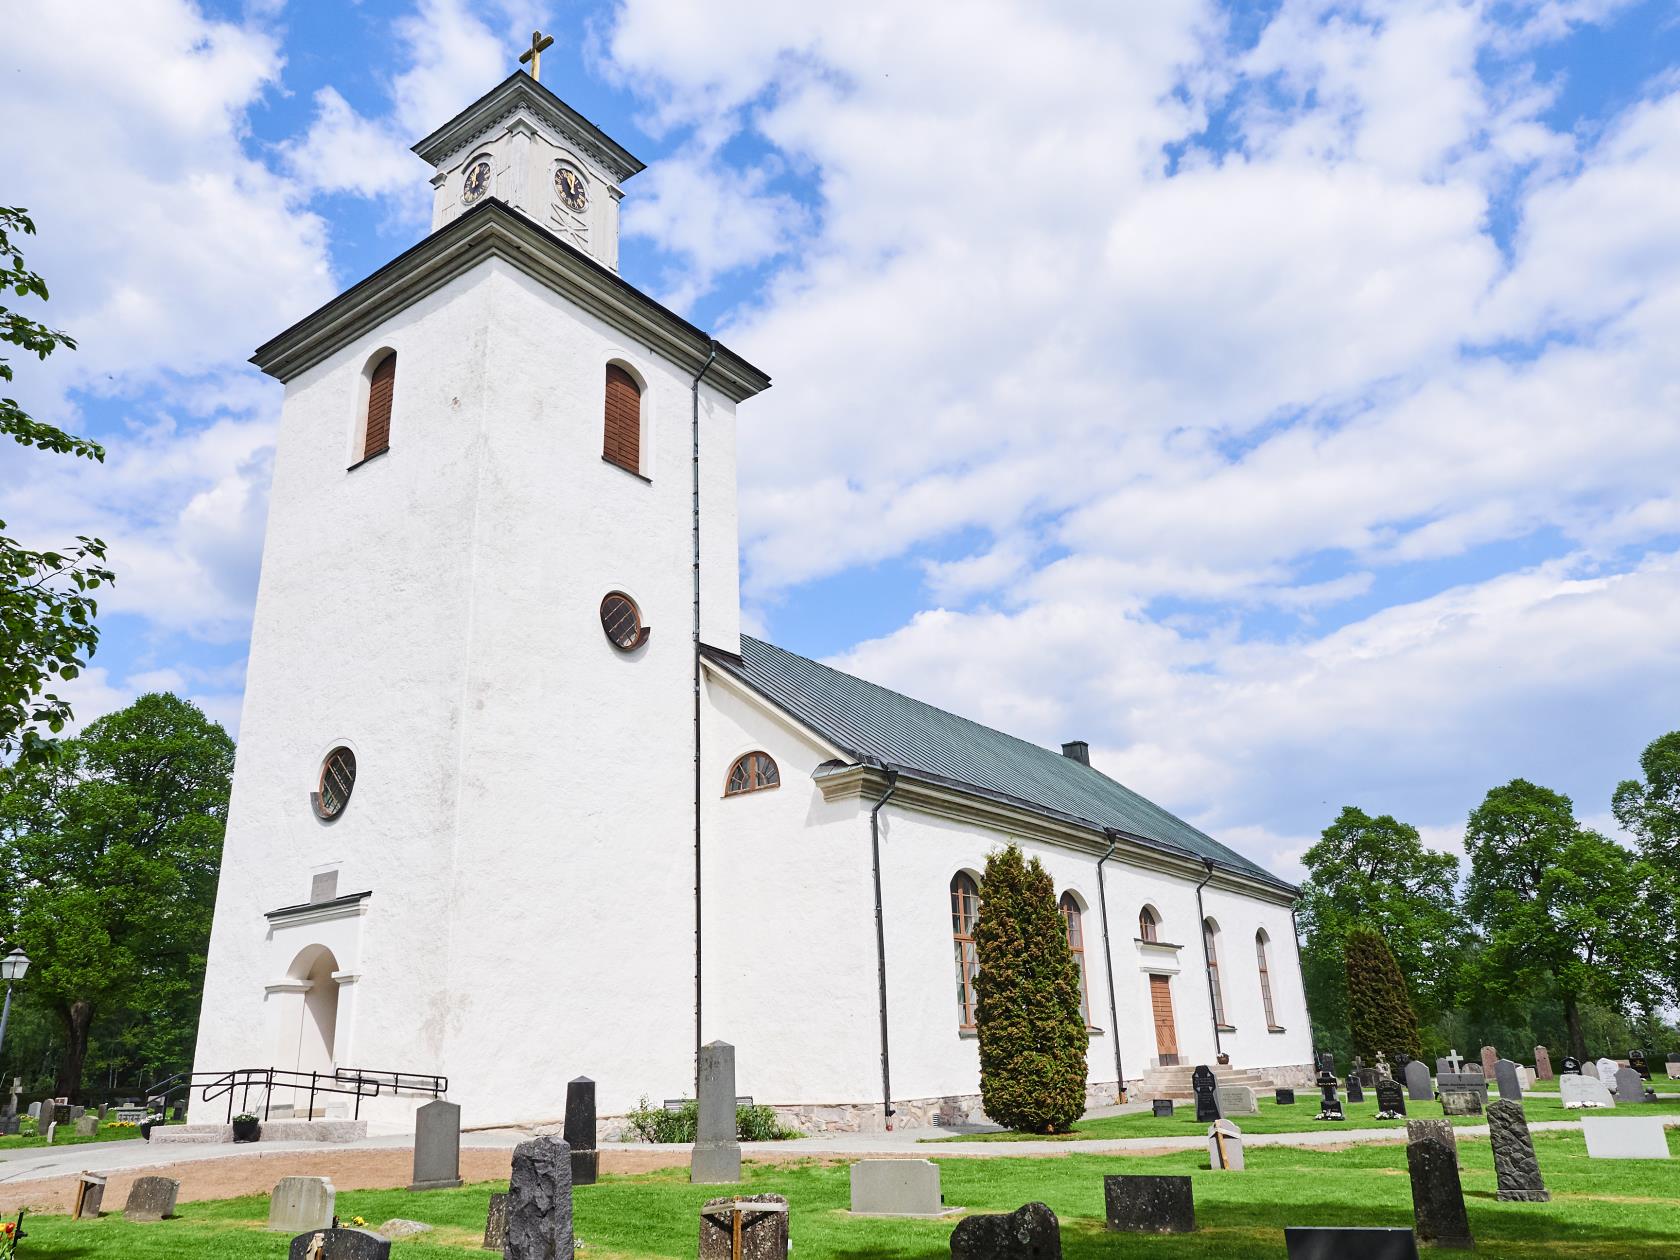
xmin=0 ymin=0 xmax=1680 ymax=874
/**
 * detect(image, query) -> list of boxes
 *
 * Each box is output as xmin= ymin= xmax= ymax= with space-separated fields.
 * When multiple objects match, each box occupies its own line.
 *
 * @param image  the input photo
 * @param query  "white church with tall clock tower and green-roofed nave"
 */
xmin=193 ymin=66 xmax=1312 ymax=1129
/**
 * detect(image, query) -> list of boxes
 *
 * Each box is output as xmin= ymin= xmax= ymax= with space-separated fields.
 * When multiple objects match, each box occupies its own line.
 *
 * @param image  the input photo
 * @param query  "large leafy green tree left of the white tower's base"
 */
xmin=0 ymin=694 xmax=234 ymax=1095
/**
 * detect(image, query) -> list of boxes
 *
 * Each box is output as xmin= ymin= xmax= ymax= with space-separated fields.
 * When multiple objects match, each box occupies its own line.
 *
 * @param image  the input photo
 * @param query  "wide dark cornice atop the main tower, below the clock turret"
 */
xmin=250 ymin=198 xmax=769 ymax=402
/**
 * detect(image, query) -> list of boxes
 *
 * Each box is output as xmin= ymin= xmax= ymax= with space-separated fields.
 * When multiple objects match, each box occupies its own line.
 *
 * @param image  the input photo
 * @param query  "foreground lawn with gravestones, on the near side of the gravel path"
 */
xmin=24 ymin=1132 xmax=1680 ymax=1260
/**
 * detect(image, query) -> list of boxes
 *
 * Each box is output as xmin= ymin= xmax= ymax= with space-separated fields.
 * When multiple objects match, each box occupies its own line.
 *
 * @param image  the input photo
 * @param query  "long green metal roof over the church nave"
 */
xmin=706 ymin=635 xmax=1292 ymax=889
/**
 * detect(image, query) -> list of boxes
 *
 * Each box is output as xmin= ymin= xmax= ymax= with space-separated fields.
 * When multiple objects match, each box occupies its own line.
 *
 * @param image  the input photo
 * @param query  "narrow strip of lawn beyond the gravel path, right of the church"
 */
xmin=922 ymin=1090 xmax=1680 ymax=1146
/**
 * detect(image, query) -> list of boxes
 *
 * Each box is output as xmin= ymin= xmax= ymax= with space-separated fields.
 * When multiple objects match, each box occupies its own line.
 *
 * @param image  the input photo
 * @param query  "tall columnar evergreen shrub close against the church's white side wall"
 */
xmin=974 ymin=845 xmax=1090 ymax=1132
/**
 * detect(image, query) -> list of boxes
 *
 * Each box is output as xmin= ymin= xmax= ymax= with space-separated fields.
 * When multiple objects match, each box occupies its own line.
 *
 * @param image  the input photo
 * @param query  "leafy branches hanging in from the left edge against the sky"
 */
xmin=0 ymin=207 xmax=114 ymax=761
